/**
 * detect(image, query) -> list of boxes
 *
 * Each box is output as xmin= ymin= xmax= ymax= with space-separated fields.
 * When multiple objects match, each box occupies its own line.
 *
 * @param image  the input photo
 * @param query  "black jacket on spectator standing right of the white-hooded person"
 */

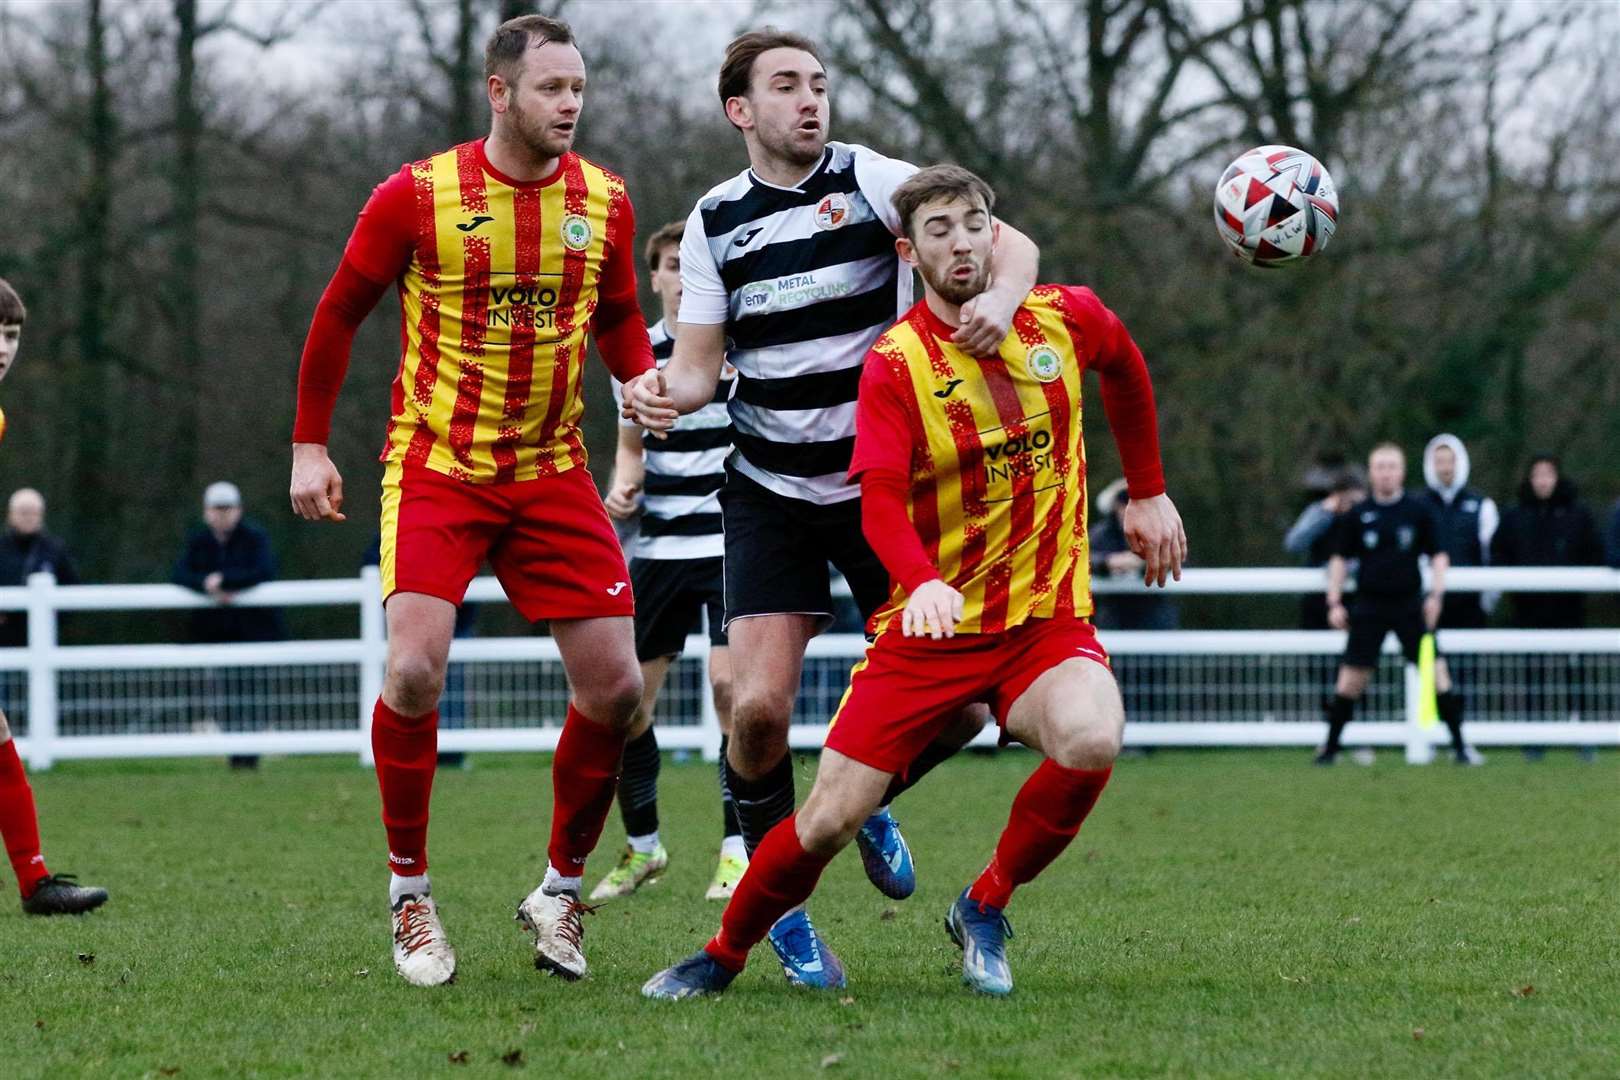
xmin=1490 ymin=476 xmax=1604 ymax=628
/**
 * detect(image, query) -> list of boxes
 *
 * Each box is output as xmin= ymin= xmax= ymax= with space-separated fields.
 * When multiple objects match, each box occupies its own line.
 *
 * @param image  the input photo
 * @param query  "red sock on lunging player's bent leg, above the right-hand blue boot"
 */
xmin=965 ymin=759 xmax=1113 ymax=908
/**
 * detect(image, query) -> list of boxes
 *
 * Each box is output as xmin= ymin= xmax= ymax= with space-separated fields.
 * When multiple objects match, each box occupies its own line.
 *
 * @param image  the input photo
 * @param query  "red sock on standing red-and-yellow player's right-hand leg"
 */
xmin=546 ymin=703 xmax=624 ymax=878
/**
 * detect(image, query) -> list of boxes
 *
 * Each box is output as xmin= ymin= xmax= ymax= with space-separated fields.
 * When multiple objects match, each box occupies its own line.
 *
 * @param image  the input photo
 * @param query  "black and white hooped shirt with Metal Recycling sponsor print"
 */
xmin=677 ymin=142 xmax=917 ymax=504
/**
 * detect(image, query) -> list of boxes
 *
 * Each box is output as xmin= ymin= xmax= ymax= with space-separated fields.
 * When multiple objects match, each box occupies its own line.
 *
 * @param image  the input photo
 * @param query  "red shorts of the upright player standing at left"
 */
xmin=379 ymin=461 xmax=635 ymax=622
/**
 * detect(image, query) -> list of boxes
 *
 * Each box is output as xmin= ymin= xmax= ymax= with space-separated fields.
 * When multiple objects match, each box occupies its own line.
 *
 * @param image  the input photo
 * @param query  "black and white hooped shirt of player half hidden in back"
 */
xmin=612 ymin=319 xmax=737 ymax=559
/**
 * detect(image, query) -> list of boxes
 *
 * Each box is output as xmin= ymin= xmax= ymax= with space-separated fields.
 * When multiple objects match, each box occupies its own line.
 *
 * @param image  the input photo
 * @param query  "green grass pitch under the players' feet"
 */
xmin=0 ymin=751 xmax=1620 ymax=1080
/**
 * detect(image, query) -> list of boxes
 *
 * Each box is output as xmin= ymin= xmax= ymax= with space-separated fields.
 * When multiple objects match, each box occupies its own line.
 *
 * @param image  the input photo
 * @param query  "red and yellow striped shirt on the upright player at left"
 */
xmin=345 ymin=141 xmax=651 ymax=483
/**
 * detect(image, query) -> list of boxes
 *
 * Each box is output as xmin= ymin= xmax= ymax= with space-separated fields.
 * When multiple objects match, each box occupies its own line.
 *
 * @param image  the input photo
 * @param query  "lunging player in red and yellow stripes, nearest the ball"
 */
xmin=643 ymin=165 xmax=1186 ymax=997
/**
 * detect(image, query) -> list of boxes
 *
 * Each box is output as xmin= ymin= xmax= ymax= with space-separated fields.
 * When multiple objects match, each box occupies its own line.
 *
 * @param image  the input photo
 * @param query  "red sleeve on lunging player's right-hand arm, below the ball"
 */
xmin=1063 ymin=285 xmax=1165 ymax=499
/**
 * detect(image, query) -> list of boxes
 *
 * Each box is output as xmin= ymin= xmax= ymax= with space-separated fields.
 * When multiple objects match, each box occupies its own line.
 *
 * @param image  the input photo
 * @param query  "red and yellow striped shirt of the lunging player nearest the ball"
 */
xmin=851 ymin=285 xmax=1163 ymax=633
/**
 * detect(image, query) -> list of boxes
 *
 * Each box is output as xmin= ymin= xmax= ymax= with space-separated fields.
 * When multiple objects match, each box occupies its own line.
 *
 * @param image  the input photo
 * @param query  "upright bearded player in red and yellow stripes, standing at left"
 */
xmin=292 ymin=16 xmax=653 ymax=986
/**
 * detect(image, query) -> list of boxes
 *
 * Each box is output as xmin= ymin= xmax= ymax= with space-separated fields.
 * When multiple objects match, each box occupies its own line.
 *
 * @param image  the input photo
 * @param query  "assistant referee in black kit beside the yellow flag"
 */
xmin=1315 ymin=442 xmax=1484 ymax=764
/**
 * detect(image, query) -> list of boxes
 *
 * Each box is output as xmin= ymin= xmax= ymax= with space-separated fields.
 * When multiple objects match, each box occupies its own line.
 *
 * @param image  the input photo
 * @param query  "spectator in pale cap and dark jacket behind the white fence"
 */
xmin=173 ymin=481 xmax=287 ymax=769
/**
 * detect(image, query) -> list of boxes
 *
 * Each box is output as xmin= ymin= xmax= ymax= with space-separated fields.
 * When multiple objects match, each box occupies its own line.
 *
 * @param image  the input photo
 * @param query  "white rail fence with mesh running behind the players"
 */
xmin=0 ymin=568 xmax=1620 ymax=769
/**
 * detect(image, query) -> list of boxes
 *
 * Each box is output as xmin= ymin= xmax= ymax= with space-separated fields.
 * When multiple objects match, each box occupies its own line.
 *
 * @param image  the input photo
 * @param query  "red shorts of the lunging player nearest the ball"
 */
xmin=826 ymin=619 xmax=1108 ymax=772
